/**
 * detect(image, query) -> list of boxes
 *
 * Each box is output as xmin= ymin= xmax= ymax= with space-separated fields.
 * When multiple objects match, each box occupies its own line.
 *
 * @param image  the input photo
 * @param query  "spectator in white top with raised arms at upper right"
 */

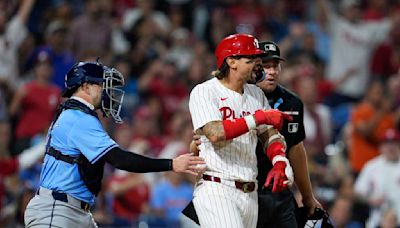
xmin=317 ymin=0 xmax=392 ymax=106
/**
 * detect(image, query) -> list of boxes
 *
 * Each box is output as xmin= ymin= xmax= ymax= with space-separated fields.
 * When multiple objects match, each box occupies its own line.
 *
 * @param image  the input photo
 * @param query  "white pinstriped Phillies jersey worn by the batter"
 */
xmin=189 ymin=78 xmax=270 ymax=181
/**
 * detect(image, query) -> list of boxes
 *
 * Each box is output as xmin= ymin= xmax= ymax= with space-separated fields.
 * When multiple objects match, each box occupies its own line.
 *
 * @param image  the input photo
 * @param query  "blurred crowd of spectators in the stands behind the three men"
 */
xmin=0 ymin=0 xmax=400 ymax=227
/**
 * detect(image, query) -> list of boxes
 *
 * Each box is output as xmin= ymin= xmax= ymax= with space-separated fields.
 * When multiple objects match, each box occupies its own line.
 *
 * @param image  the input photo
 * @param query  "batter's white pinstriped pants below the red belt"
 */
xmin=193 ymin=181 xmax=258 ymax=228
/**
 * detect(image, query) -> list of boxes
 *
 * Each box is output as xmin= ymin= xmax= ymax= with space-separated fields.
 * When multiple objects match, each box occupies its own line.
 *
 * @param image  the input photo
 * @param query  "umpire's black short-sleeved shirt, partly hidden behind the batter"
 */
xmin=256 ymin=85 xmax=305 ymax=192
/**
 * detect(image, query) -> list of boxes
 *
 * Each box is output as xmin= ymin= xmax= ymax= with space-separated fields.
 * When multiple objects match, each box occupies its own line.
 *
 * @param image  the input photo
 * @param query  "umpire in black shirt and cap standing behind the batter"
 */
xmin=256 ymin=41 xmax=322 ymax=228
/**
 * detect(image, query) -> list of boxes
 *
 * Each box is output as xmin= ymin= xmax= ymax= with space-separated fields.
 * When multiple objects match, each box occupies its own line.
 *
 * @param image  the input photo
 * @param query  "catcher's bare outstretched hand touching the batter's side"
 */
xmin=172 ymin=154 xmax=206 ymax=176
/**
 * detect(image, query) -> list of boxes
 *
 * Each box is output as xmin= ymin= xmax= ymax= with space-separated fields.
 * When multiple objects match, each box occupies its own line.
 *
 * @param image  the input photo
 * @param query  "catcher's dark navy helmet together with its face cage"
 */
xmin=62 ymin=62 xmax=125 ymax=123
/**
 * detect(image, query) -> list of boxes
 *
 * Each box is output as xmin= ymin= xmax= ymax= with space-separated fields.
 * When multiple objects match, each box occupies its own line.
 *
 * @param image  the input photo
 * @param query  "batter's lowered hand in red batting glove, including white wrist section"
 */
xmin=264 ymin=161 xmax=293 ymax=193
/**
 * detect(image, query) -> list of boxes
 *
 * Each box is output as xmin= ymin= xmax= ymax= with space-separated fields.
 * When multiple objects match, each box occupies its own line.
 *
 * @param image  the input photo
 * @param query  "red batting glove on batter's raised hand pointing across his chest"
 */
xmin=254 ymin=109 xmax=293 ymax=131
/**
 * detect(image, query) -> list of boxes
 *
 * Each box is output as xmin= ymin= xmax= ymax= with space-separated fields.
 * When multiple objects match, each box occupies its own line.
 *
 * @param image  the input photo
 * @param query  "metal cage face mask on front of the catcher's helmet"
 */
xmin=101 ymin=67 xmax=125 ymax=123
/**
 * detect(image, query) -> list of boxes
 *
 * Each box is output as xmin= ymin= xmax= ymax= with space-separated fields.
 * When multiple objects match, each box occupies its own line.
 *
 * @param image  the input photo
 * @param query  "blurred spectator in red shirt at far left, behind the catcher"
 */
xmin=9 ymin=51 xmax=61 ymax=153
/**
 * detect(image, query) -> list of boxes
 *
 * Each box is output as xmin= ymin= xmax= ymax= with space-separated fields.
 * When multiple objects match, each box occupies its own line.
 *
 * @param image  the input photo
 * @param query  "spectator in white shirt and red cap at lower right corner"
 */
xmin=354 ymin=129 xmax=400 ymax=227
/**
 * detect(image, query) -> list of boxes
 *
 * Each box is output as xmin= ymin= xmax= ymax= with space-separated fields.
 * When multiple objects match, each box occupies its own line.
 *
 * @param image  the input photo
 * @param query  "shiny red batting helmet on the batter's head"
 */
xmin=215 ymin=34 xmax=265 ymax=69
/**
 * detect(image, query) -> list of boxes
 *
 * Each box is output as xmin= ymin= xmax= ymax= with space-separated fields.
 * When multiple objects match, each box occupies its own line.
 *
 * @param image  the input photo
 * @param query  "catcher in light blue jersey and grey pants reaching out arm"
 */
xmin=25 ymin=62 xmax=204 ymax=227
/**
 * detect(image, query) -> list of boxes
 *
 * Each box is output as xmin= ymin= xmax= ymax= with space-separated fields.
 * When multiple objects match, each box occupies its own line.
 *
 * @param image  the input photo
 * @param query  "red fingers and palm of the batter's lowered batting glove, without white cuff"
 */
xmin=264 ymin=161 xmax=289 ymax=193
